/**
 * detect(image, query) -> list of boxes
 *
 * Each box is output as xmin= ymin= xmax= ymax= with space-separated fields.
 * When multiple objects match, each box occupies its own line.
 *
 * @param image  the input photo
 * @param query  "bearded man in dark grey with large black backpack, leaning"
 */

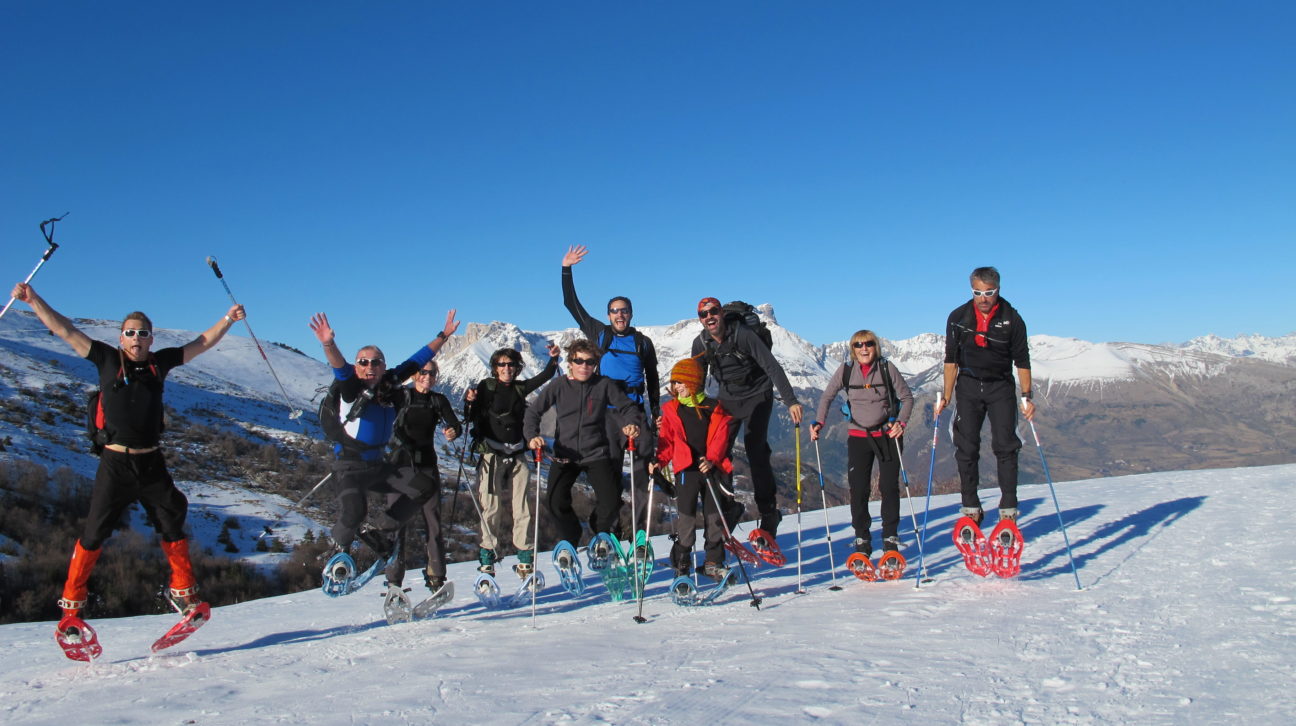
xmin=692 ymin=297 xmax=802 ymax=537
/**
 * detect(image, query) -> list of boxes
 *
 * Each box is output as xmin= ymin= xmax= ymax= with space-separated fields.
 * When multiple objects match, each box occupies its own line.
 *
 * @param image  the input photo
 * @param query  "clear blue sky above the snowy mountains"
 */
xmin=0 ymin=0 xmax=1296 ymax=357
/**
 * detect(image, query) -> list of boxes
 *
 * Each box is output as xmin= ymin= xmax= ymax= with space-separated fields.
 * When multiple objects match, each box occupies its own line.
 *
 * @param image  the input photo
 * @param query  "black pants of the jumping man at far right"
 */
xmin=954 ymin=376 xmax=1021 ymax=508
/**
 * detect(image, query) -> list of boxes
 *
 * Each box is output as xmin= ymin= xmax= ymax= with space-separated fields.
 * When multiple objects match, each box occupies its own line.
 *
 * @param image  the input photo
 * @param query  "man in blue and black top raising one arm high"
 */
xmin=562 ymin=245 xmax=661 ymax=538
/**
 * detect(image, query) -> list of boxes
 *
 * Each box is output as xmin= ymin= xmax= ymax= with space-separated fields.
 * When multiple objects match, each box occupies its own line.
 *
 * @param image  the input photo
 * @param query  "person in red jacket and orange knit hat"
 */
xmin=653 ymin=358 xmax=741 ymax=580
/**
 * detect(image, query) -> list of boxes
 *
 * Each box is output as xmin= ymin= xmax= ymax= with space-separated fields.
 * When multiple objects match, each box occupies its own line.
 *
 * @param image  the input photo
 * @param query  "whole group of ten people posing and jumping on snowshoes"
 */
xmin=13 ymin=256 xmax=1034 ymax=635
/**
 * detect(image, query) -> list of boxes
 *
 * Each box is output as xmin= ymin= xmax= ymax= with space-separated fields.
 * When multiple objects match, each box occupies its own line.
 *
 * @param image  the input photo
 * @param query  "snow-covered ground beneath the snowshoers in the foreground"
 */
xmin=0 ymin=461 xmax=1296 ymax=725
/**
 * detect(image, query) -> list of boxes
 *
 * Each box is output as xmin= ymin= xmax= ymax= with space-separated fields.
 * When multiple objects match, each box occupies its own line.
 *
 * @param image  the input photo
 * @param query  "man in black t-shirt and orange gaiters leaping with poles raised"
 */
xmin=13 ymin=283 xmax=245 ymax=638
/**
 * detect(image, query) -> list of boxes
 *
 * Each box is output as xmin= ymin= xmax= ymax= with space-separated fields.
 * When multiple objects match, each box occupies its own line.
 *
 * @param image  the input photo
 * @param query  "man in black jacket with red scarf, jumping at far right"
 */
xmin=934 ymin=267 xmax=1036 ymax=524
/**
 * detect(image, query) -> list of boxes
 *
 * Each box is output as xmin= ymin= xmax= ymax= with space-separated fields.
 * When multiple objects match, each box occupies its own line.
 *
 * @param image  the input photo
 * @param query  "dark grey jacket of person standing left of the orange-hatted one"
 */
xmin=522 ymin=375 xmax=644 ymax=464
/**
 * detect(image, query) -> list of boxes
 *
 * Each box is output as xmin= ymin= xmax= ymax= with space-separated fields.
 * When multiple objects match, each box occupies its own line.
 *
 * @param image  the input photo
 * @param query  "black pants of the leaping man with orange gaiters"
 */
xmin=80 ymin=449 xmax=189 ymax=550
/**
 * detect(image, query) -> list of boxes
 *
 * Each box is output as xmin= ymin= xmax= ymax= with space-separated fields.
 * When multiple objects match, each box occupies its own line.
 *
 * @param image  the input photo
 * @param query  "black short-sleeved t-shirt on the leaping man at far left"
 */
xmin=86 ymin=341 xmax=184 ymax=449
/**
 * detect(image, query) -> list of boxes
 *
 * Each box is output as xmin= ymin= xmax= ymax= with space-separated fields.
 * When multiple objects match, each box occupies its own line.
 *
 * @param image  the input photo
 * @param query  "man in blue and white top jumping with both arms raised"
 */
xmin=310 ymin=310 xmax=459 ymax=559
